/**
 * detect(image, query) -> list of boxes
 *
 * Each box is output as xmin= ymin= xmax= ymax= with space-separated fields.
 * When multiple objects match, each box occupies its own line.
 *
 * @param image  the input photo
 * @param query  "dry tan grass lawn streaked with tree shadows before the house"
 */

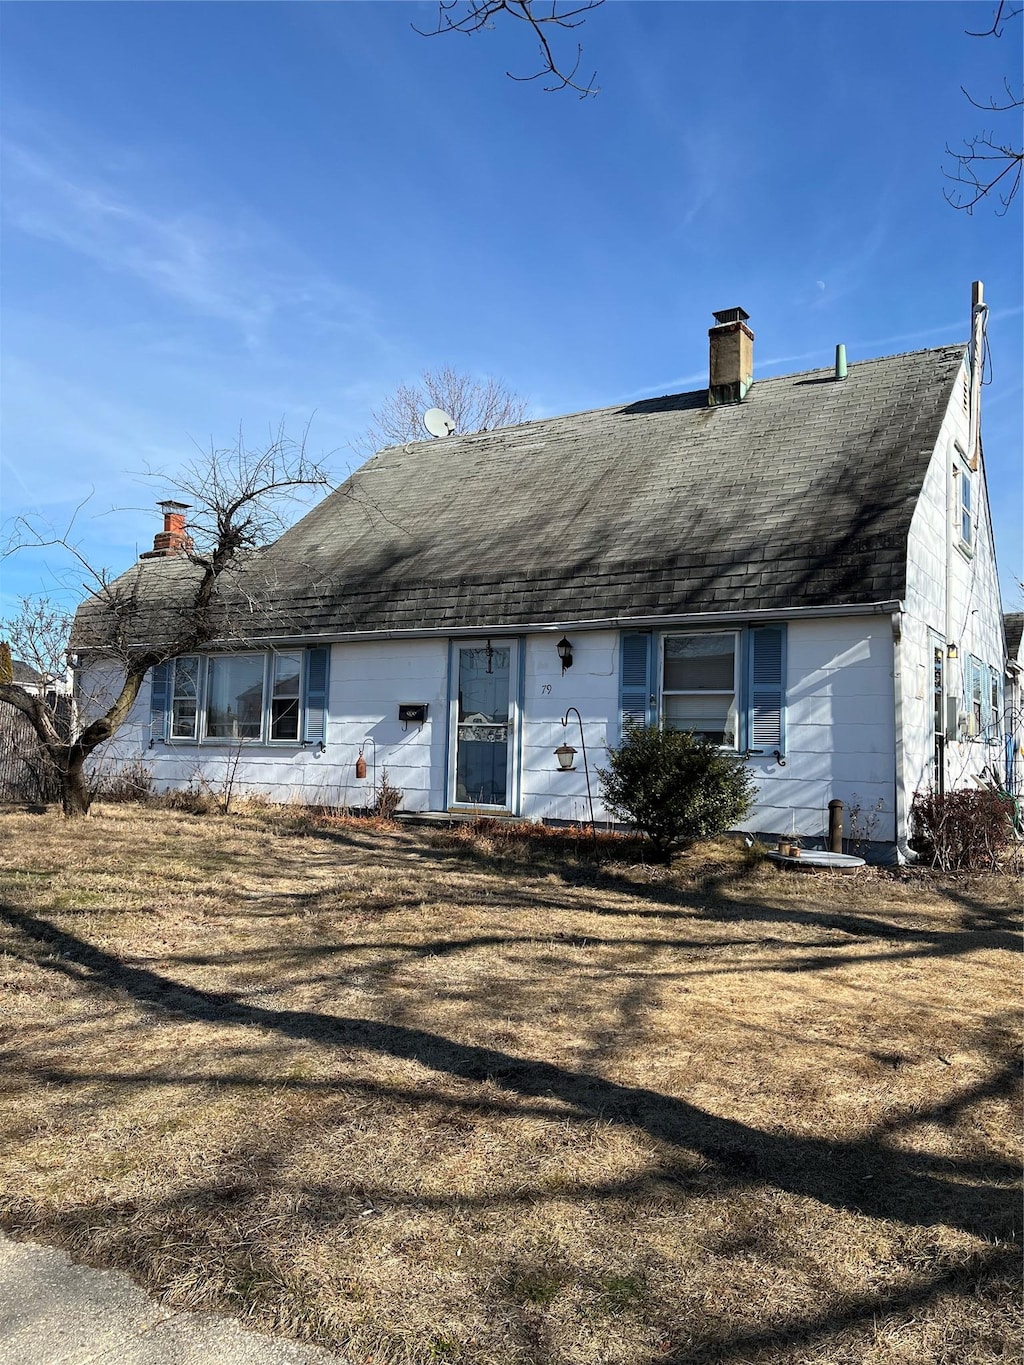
xmin=0 ymin=805 xmax=1020 ymax=1365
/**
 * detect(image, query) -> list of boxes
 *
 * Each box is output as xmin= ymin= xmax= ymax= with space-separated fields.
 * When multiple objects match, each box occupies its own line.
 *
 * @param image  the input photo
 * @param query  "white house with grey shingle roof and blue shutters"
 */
xmin=82 ymin=285 xmax=1006 ymax=856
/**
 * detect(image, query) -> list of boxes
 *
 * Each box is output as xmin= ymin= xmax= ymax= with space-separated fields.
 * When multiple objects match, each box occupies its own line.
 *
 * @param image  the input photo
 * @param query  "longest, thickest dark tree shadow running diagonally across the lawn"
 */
xmin=0 ymin=905 xmax=1017 ymax=1237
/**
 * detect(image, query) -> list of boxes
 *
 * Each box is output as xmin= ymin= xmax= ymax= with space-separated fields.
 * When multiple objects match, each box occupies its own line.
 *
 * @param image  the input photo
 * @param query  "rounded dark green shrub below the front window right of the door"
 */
xmin=598 ymin=721 xmax=754 ymax=857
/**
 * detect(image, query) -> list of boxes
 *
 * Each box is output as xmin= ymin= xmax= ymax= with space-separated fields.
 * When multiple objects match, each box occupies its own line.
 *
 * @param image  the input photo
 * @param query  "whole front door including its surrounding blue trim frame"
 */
xmin=448 ymin=640 xmax=519 ymax=811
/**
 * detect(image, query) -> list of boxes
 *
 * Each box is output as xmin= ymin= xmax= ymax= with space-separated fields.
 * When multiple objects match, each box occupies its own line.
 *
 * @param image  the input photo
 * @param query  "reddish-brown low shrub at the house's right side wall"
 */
xmin=911 ymin=788 xmax=1014 ymax=872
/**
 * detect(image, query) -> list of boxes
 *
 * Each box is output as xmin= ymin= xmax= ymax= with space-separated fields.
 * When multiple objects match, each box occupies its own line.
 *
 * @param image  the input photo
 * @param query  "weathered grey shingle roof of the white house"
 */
xmin=72 ymin=345 xmax=964 ymax=649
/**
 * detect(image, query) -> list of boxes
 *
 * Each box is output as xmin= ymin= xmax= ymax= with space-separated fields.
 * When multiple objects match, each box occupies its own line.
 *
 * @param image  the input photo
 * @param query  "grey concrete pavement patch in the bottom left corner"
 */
xmin=0 ymin=1235 xmax=347 ymax=1365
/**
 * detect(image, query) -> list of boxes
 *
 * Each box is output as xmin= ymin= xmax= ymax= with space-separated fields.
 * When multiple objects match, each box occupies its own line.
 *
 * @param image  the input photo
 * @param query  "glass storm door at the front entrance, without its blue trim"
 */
xmin=455 ymin=643 xmax=512 ymax=807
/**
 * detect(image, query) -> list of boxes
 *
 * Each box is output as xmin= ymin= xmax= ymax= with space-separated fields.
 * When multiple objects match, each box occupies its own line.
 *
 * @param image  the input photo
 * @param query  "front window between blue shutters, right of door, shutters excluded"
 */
xmin=661 ymin=632 xmax=739 ymax=748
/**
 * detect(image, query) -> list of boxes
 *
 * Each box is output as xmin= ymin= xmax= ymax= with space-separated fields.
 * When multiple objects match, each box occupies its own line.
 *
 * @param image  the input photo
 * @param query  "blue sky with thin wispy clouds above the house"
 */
xmin=0 ymin=0 xmax=1024 ymax=610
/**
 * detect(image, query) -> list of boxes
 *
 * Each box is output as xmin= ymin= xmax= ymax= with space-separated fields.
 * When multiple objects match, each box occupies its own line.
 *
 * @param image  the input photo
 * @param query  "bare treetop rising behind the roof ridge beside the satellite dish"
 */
xmin=355 ymin=364 xmax=527 ymax=455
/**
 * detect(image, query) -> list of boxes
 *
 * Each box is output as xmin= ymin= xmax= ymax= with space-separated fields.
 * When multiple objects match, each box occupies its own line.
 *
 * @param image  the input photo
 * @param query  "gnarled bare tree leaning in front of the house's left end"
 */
xmin=0 ymin=430 xmax=328 ymax=816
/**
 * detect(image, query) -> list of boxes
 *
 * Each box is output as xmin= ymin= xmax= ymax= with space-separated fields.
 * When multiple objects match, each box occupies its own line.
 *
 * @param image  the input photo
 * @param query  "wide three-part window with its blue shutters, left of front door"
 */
xmin=150 ymin=648 xmax=329 ymax=744
